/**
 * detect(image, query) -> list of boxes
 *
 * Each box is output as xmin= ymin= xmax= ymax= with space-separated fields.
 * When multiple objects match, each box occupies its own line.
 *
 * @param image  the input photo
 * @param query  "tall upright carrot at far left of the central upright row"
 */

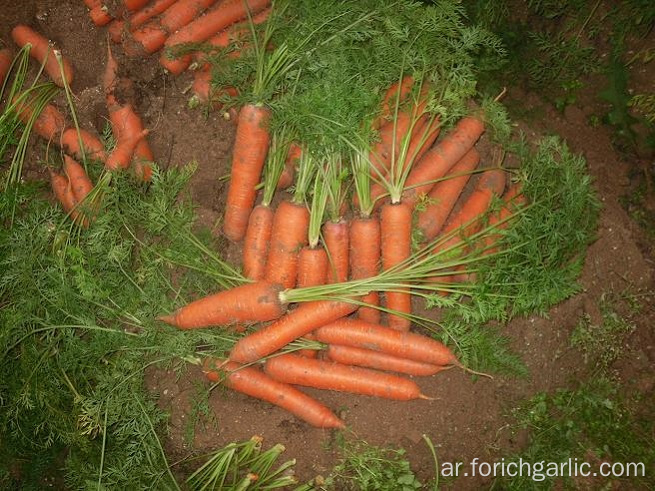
xmin=223 ymin=104 xmax=271 ymax=242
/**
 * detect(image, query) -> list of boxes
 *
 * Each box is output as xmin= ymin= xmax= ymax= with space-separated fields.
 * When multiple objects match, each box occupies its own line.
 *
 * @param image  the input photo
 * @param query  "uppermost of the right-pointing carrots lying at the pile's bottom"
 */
xmin=315 ymin=319 xmax=460 ymax=366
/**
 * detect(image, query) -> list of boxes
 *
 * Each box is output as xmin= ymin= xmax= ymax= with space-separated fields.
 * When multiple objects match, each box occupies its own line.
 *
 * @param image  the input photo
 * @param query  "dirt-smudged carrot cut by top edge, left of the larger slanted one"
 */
xmin=123 ymin=0 xmax=216 ymax=56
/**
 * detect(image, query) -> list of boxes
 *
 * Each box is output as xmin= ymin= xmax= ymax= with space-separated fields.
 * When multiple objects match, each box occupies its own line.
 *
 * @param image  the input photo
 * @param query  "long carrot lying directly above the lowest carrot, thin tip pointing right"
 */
xmin=264 ymin=354 xmax=427 ymax=401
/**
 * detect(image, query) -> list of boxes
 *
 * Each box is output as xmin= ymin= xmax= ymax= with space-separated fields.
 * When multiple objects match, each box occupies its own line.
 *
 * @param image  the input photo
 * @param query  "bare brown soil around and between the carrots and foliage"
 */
xmin=0 ymin=0 xmax=655 ymax=489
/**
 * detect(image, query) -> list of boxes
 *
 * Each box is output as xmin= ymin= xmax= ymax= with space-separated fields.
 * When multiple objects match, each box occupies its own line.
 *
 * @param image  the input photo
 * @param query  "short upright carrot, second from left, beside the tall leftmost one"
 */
xmin=243 ymin=205 xmax=273 ymax=281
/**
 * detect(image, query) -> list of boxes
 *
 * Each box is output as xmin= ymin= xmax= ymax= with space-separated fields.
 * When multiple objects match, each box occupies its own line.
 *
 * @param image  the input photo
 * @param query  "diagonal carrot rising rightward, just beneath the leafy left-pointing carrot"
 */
xmin=230 ymin=300 xmax=357 ymax=363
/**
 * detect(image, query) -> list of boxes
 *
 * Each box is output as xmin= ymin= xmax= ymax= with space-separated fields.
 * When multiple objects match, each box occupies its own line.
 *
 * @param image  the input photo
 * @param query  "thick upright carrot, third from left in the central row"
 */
xmin=265 ymin=201 xmax=309 ymax=288
